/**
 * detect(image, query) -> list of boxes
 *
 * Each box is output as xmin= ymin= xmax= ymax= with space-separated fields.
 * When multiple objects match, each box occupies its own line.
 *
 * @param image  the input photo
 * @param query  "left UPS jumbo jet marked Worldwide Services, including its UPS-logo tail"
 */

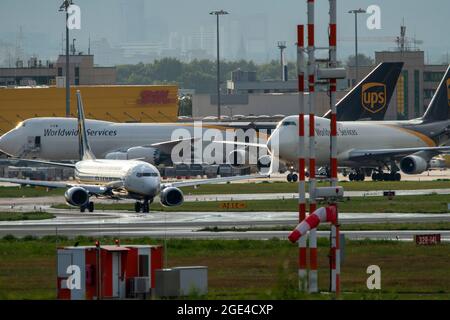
xmin=0 ymin=62 xmax=403 ymax=165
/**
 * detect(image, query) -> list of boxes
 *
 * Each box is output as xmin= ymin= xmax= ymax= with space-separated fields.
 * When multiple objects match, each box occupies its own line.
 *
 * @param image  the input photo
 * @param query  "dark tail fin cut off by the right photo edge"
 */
xmin=422 ymin=65 xmax=450 ymax=122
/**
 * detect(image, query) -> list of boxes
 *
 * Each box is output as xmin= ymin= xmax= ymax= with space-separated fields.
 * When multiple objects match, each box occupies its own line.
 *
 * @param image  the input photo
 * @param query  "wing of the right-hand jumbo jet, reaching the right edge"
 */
xmin=349 ymin=146 xmax=450 ymax=160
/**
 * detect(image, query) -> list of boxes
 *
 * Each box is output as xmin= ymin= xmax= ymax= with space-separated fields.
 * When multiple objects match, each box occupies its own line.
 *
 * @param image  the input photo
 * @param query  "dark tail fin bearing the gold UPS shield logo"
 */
xmin=324 ymin=62 xmax=403 ymax=121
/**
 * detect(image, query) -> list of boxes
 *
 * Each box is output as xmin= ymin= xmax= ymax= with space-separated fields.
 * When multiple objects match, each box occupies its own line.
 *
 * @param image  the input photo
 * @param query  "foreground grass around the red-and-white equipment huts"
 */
xmin=0 ymin=237 xmax=450 ymax=299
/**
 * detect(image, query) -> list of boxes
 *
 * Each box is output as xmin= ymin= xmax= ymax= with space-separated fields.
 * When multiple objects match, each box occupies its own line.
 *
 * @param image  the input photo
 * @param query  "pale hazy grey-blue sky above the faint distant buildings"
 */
xmin=0 ymin=0 xmax=450 ymax=62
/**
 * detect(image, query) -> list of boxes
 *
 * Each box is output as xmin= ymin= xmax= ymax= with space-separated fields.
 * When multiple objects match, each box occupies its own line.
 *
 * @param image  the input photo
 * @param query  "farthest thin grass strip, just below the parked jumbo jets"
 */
xmin=0 ymin=180 xmax=450 ymax=198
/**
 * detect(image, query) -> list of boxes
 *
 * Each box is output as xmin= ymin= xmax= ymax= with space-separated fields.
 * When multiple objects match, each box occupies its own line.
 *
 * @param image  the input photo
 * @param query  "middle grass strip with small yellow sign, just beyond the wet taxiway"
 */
xmin=53 ymin=194 xmax=450 ymax=213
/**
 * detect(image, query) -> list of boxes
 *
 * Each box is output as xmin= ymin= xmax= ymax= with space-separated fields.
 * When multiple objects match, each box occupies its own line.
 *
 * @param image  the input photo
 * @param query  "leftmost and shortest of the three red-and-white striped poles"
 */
xmin=297 ymin=25 xmax=308 ymax=291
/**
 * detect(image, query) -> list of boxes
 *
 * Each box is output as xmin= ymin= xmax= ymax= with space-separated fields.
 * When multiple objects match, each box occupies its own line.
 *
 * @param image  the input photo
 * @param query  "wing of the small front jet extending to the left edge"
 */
xmin=0 ymin=178 xmax=114 ymax=195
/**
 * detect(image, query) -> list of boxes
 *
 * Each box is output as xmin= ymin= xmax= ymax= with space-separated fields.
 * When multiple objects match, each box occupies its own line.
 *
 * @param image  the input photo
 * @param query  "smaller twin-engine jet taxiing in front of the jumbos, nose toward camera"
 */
xmin=0 ymin=91 xmax=264 ymax=212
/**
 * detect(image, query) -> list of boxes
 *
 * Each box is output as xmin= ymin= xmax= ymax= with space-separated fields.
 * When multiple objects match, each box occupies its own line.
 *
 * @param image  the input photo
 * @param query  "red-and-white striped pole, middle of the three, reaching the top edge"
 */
xmin=307 ymin=0 xmax=319 ymax=292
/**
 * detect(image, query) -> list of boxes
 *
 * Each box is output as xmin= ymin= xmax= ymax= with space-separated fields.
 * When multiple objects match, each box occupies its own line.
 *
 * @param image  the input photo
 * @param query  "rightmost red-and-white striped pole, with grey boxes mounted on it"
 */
xmin=329 ymin=0 xmax=340 ymax=294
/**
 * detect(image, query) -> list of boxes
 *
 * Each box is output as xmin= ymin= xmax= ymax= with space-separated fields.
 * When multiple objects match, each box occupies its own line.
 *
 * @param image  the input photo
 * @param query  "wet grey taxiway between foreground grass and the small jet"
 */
xmin=0 ymin=209 xmax=450 ymax=241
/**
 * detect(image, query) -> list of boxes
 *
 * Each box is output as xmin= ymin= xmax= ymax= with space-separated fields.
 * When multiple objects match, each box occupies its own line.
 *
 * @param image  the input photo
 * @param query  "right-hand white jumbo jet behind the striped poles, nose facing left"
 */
xmin=267 ymin=66 xmax=450 ymax=180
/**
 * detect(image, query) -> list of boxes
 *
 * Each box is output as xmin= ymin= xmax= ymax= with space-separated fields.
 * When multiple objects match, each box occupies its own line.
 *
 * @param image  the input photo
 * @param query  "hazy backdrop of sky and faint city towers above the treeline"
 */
xmin=0 ymin=0 xmax=450 ymax=66
